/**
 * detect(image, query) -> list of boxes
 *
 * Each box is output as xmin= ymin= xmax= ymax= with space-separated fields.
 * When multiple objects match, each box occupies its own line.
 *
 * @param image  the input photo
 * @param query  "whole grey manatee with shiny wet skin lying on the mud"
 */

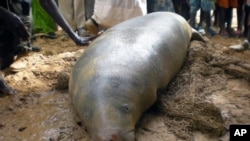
xmin=69 ymin=12 xmax=204 ymax=141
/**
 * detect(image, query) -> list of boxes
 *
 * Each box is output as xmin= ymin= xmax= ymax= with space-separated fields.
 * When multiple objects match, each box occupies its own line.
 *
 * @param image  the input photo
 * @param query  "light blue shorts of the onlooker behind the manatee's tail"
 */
xmin=189 ymin=0 xmax=214 ymax=13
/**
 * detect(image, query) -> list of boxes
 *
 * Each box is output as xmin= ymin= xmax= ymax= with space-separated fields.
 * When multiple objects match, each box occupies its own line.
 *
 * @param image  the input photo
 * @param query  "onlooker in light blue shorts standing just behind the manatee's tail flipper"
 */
xmin=189 ymin=0 xmax=216 ymax=36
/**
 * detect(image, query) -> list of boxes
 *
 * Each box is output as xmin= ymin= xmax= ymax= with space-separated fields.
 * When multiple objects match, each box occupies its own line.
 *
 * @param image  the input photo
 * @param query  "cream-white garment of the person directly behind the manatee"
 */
xmin=92 ymin=0 xmax=147 ymax=28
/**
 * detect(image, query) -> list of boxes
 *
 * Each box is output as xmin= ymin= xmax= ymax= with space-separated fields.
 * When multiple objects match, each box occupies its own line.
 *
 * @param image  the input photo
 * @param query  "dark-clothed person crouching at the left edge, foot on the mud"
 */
xmin=0 ymin=6 xmax=29 ymax=94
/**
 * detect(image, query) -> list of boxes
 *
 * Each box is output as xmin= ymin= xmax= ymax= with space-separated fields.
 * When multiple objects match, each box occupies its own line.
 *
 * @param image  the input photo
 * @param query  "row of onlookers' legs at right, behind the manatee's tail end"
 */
xmin=164 ymin=0 xmax=250 ymax=37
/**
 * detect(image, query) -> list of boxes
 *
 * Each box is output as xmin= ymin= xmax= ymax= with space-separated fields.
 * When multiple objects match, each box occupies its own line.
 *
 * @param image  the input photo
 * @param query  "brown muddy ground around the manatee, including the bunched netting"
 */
xmin=0 ymin=31 xmax=250 ymax=141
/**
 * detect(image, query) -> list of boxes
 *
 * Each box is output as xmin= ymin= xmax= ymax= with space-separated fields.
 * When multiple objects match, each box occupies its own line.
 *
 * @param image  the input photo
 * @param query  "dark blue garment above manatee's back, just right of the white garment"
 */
xmin=147 ymin=0 xmax=175 ymax=13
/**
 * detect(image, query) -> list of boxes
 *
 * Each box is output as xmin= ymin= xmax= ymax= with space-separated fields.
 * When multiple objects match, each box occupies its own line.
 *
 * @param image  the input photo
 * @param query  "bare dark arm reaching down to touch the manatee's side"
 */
xmin=40 ymin=0 xmax=101 ymax=46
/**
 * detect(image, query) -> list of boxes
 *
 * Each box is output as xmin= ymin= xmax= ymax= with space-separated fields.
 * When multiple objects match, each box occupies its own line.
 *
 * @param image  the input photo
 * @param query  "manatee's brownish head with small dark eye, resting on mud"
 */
xmin=80 ymin=92 xmax=137 ymax=141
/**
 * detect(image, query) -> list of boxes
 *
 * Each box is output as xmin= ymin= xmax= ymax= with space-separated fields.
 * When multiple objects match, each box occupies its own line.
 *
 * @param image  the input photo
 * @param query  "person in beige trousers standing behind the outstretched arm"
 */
xmin=58 ymin=0 xmax=89 ymax=37
